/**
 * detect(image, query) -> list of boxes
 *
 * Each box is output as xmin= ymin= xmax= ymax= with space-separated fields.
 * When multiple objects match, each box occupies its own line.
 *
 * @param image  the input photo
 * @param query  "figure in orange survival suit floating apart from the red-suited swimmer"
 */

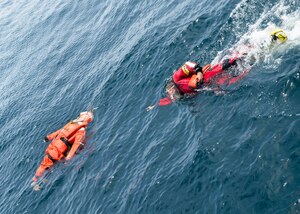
xmin=32 ymin=111 xmax=94 ymax=182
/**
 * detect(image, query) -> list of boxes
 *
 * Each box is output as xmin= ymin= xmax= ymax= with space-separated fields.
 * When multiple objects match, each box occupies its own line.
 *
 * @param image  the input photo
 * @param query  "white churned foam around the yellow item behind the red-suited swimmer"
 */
xmin=212 ymin=0 xmax=300 ymax=66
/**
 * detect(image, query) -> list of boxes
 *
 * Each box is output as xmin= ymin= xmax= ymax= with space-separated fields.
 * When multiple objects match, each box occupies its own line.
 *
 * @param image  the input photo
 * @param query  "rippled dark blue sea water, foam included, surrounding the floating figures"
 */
xmin=0 ymin=0 xmax=300 ymax=214
